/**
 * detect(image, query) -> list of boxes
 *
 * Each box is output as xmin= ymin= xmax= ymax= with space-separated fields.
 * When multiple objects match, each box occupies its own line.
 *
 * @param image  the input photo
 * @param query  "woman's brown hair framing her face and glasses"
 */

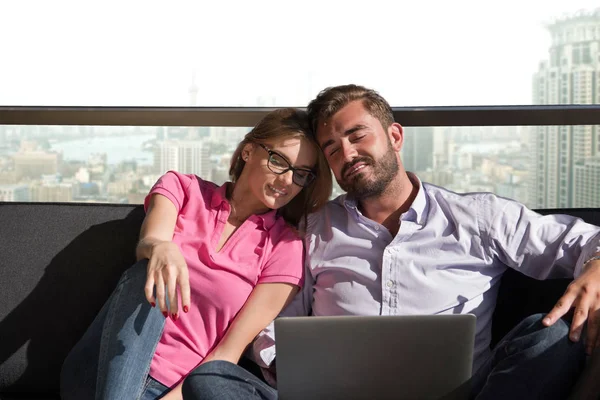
xmin=229 ymin=108 xmax=332 ymax=227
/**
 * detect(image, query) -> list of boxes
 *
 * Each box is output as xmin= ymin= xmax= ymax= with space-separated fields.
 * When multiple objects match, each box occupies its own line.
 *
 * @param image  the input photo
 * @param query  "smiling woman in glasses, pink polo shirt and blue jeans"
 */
xmin=61 ymin=109 xmax=331 ymax=399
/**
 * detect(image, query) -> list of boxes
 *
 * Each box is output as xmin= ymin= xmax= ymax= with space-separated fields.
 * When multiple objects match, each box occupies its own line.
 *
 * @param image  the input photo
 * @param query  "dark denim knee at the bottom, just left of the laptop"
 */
xmin=182 ymin=360 xmax=277 ymax=400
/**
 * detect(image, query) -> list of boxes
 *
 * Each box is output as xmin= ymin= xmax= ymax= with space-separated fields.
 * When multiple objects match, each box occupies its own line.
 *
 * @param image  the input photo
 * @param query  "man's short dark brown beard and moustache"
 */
xmin=338 ymin=143 xmax=399 ymax=200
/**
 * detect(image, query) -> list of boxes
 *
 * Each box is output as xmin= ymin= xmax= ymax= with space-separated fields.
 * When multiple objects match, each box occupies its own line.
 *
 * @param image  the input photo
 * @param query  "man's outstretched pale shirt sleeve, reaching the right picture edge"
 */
xmin=478 ymin=194 xmax=600 ymax=279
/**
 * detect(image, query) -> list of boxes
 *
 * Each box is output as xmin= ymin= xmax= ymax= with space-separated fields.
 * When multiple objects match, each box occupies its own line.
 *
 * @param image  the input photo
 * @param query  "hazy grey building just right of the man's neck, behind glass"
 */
xmin=402 ymin=127 xmax=434 ymax=172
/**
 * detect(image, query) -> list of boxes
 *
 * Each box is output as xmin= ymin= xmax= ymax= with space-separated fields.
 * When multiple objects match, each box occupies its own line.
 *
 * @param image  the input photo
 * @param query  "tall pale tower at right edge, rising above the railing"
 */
xmin=528 ymin=9 xmax=600 ymax=208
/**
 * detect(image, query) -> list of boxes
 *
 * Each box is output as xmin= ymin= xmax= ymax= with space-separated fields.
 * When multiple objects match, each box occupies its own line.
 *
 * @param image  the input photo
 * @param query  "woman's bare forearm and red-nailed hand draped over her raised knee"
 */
xmin=136 ymin=194 xmax=190 ymax=319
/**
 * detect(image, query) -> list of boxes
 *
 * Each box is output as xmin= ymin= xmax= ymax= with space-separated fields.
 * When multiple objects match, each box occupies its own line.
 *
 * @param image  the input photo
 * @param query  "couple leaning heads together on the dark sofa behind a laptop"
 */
xmin=61 ymin=85 xmax=600 ymax=400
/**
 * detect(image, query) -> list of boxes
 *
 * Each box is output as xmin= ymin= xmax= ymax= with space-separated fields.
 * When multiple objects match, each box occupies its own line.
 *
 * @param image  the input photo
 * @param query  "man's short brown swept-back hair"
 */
xmin=306 ymin=85 xmax=394 ymax=132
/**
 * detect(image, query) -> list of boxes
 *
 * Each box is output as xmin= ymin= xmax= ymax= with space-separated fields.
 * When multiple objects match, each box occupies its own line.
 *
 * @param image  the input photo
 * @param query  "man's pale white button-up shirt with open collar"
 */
xmin=253 ymin=174 xmax=600 ymax=372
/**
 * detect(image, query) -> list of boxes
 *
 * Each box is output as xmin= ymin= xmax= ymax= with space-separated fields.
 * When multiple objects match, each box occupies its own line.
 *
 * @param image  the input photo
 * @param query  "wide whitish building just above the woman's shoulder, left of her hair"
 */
xmin=154 ymin=140 xmax=211 ymax=179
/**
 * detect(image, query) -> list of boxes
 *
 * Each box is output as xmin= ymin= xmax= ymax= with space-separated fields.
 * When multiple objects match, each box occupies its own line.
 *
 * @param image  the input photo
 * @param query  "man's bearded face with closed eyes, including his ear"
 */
xmin=317 ymin=101 xmax=403 ymax=199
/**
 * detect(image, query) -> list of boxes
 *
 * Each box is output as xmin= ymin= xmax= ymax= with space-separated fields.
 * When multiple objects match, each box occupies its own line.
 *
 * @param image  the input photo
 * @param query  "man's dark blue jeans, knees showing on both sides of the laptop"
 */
xmin=183 ymin=314 xmax=585 ymax=400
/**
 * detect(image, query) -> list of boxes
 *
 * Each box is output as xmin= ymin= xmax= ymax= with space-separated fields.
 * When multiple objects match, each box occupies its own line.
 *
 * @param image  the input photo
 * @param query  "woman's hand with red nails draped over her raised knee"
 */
xmin=144 ymin=241 xmax=190 ymax=321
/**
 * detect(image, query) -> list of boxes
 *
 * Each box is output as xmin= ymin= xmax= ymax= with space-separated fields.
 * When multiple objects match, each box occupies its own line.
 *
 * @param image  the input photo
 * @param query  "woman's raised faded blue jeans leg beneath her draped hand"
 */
xmin=60 ymin=260 xmax=165 ymax=400
